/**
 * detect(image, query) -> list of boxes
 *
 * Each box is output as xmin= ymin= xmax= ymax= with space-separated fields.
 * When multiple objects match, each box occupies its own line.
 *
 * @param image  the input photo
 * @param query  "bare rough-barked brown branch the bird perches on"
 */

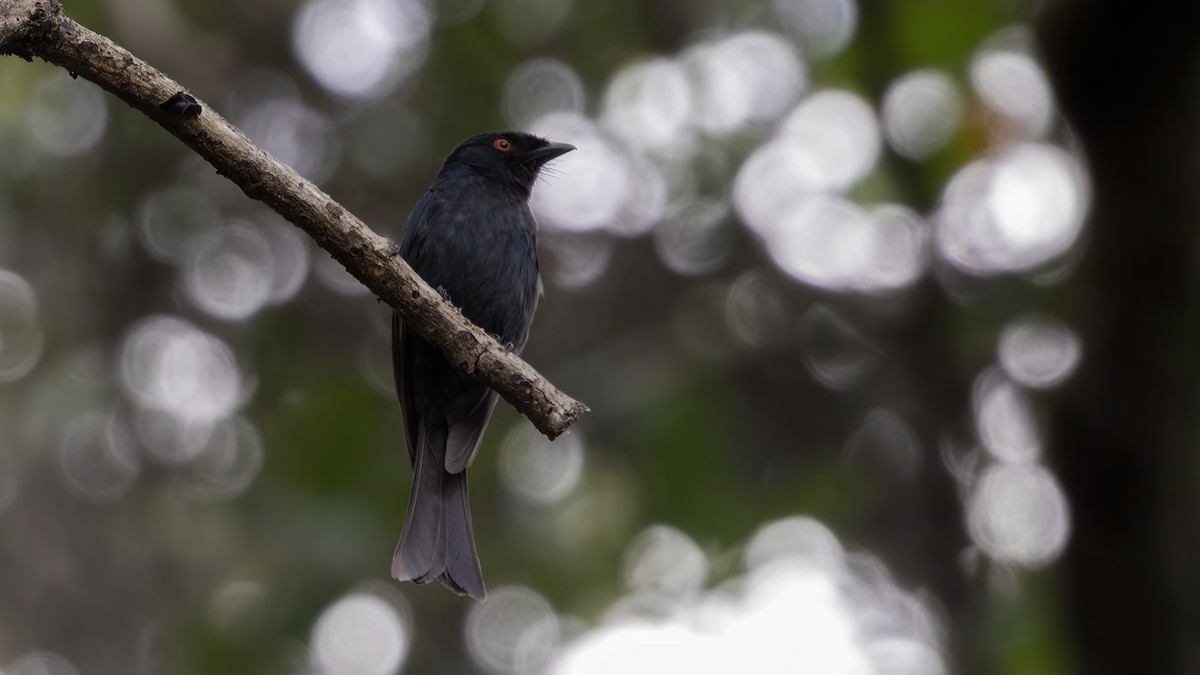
xmin=0 ymin=0 xmax=588 ymax=438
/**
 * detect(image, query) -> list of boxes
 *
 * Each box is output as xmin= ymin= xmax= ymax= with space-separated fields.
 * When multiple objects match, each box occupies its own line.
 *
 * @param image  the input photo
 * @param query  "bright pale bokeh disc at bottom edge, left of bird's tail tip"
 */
xmin=310 ymin=592 xmax=412 ymax=675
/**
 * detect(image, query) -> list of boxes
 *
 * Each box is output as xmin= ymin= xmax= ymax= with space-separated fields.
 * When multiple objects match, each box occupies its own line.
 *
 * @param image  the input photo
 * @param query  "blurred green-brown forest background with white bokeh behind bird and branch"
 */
xmin=0 ymin=0 xmax=1200 ymax=675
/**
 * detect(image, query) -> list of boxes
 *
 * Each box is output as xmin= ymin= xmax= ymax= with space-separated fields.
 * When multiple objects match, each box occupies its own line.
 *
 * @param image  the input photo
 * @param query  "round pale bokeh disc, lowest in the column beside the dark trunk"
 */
xmin=967 ymin=464 xmax=1070 ymax=567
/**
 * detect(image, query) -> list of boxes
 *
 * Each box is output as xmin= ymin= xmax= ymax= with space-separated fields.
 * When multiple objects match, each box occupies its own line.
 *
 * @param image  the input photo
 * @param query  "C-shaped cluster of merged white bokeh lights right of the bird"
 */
xmin=733 ymin=91 xmax=892 ymax=285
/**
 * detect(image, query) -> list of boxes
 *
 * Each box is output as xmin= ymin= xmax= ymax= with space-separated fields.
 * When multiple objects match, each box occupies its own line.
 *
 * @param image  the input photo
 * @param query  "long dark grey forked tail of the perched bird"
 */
xmin=391 ymin=420 xmax=487 ymax=601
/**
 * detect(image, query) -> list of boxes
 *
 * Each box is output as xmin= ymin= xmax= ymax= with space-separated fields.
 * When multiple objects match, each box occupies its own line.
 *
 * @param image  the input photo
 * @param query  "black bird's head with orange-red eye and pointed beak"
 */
xmin=443 ymin=131 xmax=575 ymax=197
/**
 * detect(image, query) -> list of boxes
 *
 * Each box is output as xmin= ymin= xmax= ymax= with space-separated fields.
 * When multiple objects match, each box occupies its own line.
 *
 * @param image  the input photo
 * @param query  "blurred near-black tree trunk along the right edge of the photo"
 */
xmin=1038 ymin=0 xmax=1200 ymax=675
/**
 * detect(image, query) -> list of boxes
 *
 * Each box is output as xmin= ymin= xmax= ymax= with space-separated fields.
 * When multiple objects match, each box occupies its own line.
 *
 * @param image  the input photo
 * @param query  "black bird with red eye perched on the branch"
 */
xmin=391 ymin=131 xmax=575 ymax=601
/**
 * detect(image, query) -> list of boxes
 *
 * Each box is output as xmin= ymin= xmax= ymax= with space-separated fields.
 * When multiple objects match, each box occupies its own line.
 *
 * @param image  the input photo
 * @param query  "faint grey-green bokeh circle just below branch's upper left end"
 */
xmin=29 ymin=71 xmax=108 ymax=157
